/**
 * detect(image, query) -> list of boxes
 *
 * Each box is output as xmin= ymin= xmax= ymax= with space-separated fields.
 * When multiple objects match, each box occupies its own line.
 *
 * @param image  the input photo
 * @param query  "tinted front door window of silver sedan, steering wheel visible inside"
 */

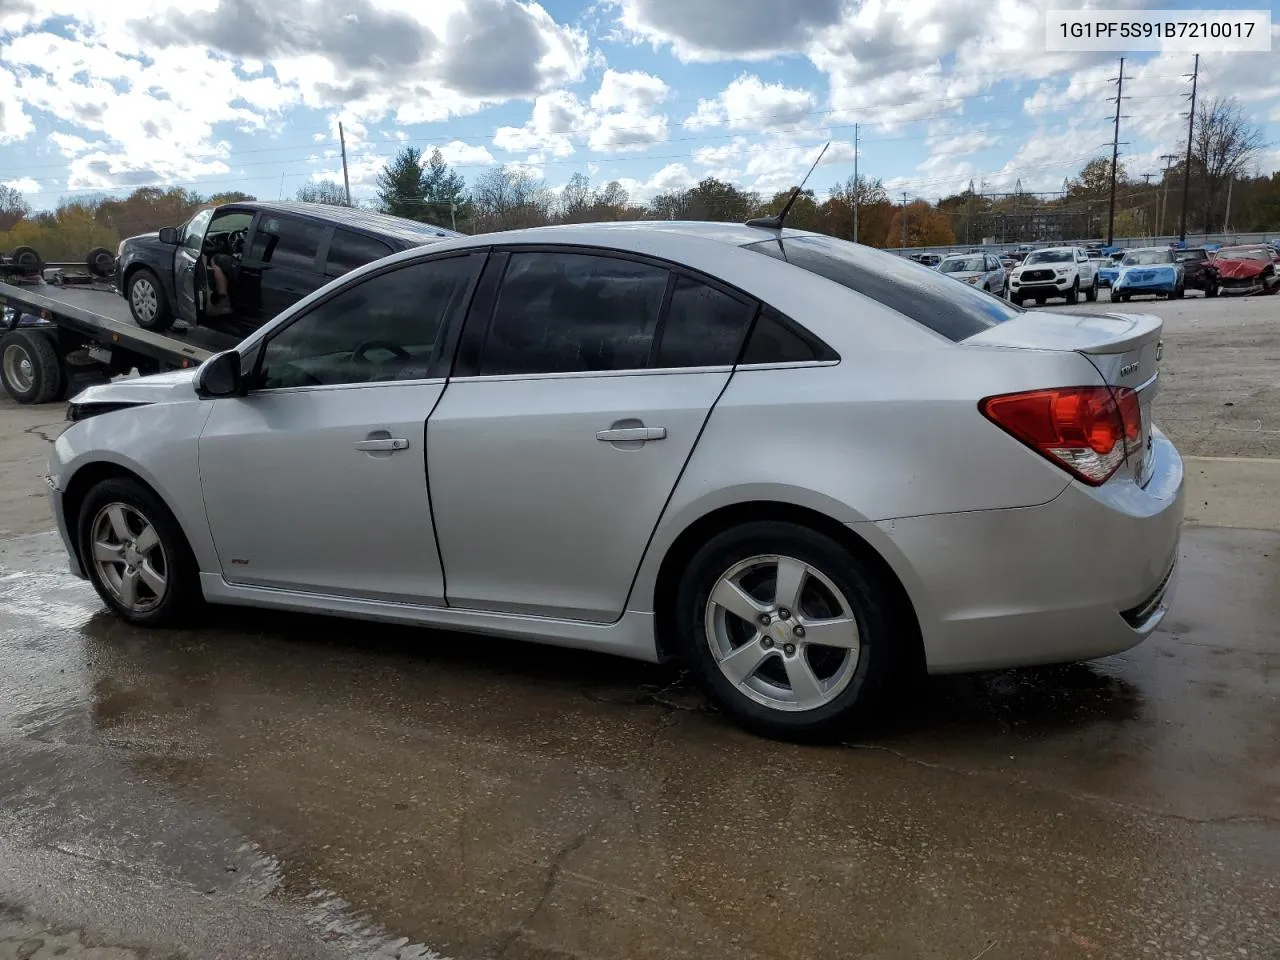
xmin=259 ymin=255 xmax=484 ymax=389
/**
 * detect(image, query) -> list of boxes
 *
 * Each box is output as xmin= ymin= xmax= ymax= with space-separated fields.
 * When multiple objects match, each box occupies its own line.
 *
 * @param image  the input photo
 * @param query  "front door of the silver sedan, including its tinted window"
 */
xmin=200 ymin=253 xmax=485 ymax=604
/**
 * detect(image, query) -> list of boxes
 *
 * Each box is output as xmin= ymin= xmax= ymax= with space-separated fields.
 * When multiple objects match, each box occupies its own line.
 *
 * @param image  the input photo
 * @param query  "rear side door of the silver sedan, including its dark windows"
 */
xmin=426 ymin=248 xmax=754 ymax=622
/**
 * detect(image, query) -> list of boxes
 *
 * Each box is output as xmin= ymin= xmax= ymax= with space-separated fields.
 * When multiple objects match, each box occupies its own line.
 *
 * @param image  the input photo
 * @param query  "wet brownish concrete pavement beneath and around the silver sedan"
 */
xmin=0 ymin=527 xmax=1280 ymax=960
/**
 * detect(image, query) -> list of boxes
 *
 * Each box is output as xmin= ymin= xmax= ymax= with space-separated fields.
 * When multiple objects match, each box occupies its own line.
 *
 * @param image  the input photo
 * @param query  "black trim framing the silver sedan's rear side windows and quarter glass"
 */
xmin=448 ymin=243 xmax=840 ymax=380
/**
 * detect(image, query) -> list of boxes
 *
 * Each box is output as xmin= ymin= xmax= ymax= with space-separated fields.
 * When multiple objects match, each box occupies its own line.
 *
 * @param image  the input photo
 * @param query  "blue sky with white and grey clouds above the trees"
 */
xmin=0 ymin=0 xmax=1280 ymax=209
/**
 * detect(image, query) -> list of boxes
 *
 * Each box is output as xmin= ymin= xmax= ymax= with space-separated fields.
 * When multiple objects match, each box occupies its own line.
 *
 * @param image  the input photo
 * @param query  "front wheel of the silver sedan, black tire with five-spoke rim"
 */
xmin=77 ymin=476 xmax=204 ymax=627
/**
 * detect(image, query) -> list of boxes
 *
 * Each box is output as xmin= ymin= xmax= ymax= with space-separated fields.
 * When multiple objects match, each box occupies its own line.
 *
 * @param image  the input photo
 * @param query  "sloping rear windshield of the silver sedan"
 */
xmin=744 ymin=237 xmax=1023 ymax=343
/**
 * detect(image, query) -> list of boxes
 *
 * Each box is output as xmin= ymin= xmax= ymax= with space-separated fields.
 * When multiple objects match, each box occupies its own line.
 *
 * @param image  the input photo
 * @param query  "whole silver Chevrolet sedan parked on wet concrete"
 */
xmin=47 ymin=221 xmax=1184 ymax=737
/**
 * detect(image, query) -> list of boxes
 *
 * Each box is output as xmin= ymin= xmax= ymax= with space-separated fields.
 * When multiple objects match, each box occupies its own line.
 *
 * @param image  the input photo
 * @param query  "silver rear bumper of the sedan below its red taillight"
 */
xmin=859 ymin=429 xmax=1184 ymax=673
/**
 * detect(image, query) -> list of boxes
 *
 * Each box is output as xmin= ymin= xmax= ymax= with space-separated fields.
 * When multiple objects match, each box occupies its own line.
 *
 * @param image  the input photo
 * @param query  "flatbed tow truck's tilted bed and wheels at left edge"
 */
xmin=0 ymin=271 xmax=233 ymax=403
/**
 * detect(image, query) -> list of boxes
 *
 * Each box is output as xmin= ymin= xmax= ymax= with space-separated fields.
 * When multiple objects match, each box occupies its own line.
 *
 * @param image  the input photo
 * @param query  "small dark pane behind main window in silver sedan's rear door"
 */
xmin=653 ymin=275 xmax=755 ymax=367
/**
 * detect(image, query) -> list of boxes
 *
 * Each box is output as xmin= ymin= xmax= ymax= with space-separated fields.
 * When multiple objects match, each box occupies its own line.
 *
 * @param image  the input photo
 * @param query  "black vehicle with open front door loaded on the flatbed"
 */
xmin=115 ymin=201 xmax=460 ymax=338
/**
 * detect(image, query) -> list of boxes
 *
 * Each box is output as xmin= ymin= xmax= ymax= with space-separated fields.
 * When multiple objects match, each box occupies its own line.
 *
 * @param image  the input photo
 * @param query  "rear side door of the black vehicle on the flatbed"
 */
xmin=241 ymin=211 xmax=333 ymax=326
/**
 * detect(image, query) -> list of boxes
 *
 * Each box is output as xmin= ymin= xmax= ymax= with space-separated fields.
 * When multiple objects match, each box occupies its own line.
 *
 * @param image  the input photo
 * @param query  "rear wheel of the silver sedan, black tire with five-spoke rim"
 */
xmin=675 ymin=521 xmax=902 ymax=740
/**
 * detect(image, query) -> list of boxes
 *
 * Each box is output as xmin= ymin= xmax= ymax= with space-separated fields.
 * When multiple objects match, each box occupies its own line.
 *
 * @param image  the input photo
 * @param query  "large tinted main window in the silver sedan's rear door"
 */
xmin=477 ymin=251 xmax=669 ymax=376
